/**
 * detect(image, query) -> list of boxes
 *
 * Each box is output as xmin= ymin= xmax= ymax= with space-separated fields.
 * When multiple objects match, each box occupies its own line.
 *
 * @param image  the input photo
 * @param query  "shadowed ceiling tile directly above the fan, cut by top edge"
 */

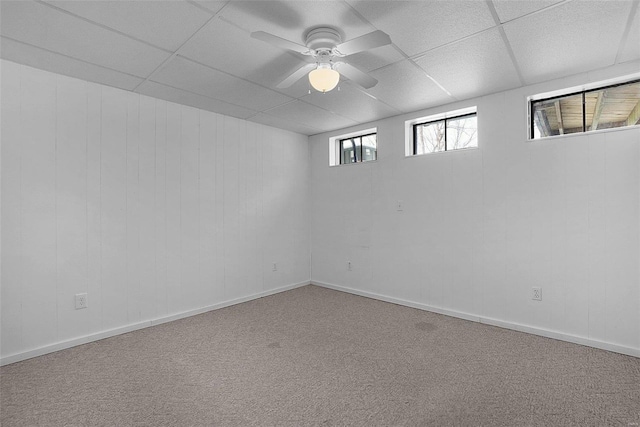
xmin=221 ymin=0 xmax=375 ymax=48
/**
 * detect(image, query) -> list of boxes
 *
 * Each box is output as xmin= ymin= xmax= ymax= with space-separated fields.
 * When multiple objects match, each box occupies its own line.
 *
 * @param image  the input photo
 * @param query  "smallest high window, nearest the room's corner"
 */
xmin=329 ymin=128 xmax=378 ymax=166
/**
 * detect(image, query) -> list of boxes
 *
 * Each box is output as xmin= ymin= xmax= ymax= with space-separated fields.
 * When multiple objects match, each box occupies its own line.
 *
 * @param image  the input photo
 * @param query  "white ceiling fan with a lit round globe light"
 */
xmin=251 ymin=26 xmax=391 ymax=92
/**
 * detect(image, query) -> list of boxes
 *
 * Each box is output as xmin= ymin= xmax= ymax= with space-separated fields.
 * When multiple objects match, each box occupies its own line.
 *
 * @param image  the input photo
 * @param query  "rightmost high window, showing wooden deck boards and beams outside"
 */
xmin=529 ymin=79 xmax=640 ymax=140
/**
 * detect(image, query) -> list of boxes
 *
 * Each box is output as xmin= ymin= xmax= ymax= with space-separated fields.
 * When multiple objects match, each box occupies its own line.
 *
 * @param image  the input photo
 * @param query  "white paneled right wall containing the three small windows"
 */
xmin=310 ymin=61 xmax=640 ymax=356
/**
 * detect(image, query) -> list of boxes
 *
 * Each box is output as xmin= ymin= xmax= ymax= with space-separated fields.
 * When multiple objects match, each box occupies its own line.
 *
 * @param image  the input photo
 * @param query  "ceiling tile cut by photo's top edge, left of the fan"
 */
xmin=47 ymin=0 xmax=211 ymax=52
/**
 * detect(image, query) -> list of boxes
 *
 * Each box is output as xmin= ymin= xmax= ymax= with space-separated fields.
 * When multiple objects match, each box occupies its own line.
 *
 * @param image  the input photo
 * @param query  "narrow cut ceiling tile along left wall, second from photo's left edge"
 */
xmin=136 ymin=81 xmax=257 ymax=119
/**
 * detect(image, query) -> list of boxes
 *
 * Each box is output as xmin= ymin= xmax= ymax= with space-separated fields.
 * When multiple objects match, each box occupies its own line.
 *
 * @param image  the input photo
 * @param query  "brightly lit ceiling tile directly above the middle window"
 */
xmin=416 ymin=28 xmax=521 ymax=99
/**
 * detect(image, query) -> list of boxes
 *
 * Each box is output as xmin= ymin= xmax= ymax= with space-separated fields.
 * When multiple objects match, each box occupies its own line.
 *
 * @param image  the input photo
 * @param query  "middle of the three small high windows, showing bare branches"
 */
xmin=405 ymin=107 xmax=478 ymax=156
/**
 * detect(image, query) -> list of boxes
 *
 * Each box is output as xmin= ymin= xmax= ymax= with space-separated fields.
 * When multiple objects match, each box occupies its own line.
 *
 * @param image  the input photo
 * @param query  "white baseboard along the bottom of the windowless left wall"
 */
xmin=0 ymin=281 xmax=310 ymax=366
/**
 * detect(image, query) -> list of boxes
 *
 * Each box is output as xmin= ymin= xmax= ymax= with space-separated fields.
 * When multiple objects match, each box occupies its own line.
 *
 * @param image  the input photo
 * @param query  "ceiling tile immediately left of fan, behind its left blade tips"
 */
xmin=180 ymin=15 xmax=306 ymax=88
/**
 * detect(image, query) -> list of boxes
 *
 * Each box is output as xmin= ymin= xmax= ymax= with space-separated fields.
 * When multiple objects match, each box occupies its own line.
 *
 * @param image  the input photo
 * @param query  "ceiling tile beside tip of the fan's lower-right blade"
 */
xmin=367 ymin=60 xmax=455 ymax=112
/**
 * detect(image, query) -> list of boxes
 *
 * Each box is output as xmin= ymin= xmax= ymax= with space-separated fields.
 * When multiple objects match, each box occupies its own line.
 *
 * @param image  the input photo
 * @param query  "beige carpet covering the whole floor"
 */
xmin=0 ymin=286 xmax=640 ymax=427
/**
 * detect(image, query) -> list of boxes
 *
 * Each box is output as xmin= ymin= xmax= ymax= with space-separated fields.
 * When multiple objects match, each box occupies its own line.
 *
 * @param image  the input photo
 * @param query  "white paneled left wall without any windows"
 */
xmin=1 ymin=61 xmax=309 ymax=362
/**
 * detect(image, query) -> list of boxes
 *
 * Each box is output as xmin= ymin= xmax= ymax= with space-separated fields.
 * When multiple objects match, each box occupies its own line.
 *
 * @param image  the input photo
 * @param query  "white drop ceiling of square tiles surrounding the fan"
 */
xmin=0 ymin=0 xmax=640 ymax=135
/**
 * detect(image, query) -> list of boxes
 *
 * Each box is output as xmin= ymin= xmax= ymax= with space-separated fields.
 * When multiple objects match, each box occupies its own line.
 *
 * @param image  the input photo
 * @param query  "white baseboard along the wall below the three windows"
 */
xmin=311 ymin=280 xmax=640 ymax=357
